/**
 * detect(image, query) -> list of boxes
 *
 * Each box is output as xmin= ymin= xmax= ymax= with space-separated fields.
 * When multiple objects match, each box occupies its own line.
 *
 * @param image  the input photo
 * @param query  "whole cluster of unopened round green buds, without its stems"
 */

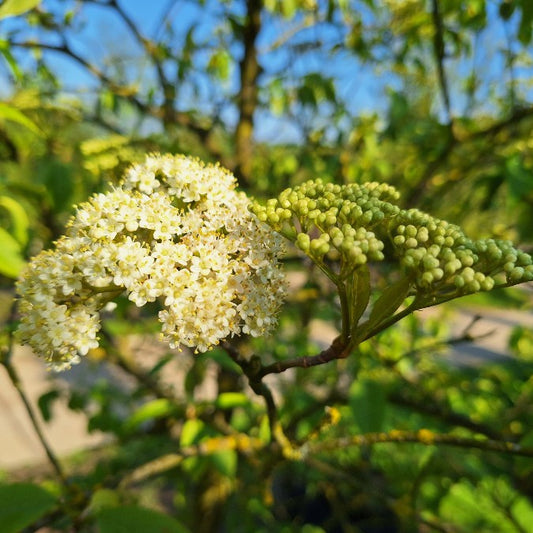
xmin=251 ymin=179 xmax=533 ymax=302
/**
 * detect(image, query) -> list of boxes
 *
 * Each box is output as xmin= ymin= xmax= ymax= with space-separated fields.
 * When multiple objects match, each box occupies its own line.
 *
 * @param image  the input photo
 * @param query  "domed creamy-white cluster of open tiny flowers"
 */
xmin=17 ymin=154 xmax=285 ymax=369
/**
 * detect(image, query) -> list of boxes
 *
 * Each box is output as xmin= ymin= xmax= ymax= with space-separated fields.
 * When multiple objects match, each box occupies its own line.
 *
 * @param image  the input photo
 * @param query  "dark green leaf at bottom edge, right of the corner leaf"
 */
xmin=96 ymin=505 xmax=189 ymax=533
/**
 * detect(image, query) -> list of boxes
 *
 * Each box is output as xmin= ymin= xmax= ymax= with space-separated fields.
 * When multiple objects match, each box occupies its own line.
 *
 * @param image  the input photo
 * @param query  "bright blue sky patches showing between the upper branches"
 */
xmin=0 ymin=0 xmax=528 ymax=141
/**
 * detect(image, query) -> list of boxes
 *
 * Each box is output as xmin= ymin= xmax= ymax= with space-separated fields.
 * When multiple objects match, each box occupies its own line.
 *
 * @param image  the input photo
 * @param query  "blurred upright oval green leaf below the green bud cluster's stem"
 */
xmin=349 ymin=379 xmax=387 ymax=433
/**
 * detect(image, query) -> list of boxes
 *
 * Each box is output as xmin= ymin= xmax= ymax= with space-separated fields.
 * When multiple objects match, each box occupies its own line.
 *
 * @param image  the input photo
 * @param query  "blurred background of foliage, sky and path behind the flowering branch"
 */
xmin=0 ymin=0 xmax=533 ymax=533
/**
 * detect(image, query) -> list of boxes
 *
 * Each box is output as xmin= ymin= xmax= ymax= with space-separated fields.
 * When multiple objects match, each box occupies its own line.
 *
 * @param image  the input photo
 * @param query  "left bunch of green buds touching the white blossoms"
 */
xmin=252 ymin=179 xmax=400 ymax=273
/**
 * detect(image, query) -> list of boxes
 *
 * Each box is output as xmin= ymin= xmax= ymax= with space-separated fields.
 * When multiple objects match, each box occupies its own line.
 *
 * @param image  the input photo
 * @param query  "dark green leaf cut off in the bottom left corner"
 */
xmin=0 ymin=483 xmax=56 ymax=533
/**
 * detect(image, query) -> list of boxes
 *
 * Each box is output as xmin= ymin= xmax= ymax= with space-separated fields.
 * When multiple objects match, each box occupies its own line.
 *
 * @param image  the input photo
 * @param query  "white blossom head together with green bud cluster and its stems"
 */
xmin=17 ymin=155 xmax=533 ymax=369
